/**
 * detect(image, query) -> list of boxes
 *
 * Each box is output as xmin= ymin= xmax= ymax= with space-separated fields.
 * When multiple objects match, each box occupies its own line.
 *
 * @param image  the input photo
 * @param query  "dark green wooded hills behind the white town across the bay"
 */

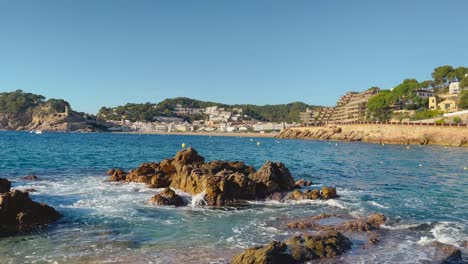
xmin=97 ymin=97 xmax=316 ymax=122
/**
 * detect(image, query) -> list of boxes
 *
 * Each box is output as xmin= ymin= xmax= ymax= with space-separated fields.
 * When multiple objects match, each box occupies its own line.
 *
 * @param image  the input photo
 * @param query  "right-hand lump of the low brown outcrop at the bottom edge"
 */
xmin=285 ymin=231 xmax=352 ymax=262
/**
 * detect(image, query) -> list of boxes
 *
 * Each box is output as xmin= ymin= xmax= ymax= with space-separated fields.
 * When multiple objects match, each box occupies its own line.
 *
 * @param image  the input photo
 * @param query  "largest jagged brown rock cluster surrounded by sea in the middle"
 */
xmin=108 ymin=148 xmax=295 ymax=206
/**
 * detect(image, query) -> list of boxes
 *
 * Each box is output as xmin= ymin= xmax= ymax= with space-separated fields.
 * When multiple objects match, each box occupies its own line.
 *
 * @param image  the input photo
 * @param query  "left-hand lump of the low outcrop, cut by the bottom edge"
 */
xmin=231 ymin=241 xmax=295 ymax=264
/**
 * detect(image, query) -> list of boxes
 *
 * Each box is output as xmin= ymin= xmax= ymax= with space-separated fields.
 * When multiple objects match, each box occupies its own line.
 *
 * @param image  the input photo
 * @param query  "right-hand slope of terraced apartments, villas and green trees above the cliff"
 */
xmin=300 ymin=66 xmax=468 ymax=126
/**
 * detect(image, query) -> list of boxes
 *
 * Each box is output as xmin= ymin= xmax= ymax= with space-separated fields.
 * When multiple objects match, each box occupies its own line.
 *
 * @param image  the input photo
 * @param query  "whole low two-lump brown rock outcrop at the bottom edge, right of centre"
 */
xmin=231 ymin=231 xmax=352 ymax=264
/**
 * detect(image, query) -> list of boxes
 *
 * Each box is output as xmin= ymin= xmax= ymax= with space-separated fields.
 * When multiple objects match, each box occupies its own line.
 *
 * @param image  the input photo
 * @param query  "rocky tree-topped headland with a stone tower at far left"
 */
xmin=0 ymin=90 xmax=104 ymax=131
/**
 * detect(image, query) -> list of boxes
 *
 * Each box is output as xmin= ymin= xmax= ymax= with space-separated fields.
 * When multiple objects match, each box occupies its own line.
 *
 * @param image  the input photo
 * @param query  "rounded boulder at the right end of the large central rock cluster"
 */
xmin=249 ymin=161 xmax=295 ymax=197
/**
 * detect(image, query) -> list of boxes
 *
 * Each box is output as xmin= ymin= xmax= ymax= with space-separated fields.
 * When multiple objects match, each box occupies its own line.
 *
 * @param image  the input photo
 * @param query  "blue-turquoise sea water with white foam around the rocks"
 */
xmin=0 ymin=132 xmax=468 ymax=263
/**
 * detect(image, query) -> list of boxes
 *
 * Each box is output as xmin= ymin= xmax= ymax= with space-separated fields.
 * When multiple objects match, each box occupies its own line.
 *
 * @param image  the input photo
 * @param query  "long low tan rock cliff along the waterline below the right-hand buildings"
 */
xmin=277 ymin=124 xmax=468 ymax=147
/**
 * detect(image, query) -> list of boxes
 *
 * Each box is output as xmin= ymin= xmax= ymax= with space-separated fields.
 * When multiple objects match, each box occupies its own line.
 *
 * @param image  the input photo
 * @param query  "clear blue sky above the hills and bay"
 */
xmin=0 ymin=0 xmax=468 ymax=113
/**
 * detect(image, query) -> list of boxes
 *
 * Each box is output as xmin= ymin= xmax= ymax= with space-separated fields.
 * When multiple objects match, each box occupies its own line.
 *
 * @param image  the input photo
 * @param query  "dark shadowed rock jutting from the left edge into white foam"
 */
xmin=0 ymin=190 xmax=61 ymax=234
